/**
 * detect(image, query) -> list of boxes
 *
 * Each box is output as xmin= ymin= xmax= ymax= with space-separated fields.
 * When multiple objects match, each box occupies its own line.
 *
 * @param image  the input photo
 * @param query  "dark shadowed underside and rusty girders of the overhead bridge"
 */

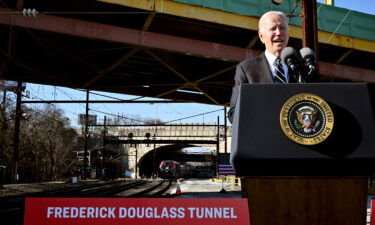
xmin=0 ymin=0 xmax=375 ymax=105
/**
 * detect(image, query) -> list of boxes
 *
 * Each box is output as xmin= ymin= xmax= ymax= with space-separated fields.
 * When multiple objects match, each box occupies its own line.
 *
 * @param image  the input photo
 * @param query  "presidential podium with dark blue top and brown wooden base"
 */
xmin=231 ymin=83 xmax=375 ymax=225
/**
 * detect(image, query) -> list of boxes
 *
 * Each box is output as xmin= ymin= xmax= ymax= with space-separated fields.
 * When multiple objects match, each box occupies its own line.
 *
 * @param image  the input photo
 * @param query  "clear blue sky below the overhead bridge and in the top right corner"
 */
xmin=6 ymin=0 xmax=375 ymax=128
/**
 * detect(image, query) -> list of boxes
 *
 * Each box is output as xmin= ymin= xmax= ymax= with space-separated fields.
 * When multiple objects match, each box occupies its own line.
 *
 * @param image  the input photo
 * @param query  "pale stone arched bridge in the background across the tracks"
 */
xmin=82 ymin=123 xmax=232 ymax=177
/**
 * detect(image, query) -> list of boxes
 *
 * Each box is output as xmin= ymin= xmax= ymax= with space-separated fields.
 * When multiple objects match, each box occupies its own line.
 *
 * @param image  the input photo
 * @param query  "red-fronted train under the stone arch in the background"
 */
xmin=159 ymin=160 xmax=195 ymax=179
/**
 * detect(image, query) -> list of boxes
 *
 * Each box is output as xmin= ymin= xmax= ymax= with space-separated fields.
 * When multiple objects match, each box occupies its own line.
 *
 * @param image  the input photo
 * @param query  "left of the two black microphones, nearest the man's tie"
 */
xmin=280 ymin=47 xmax=305 ymax=83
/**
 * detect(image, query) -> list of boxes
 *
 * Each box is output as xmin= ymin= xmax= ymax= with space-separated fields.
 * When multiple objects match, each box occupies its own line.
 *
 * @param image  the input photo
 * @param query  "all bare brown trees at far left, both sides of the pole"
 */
xmin=0 ymin=96 xmax=77 ymax=182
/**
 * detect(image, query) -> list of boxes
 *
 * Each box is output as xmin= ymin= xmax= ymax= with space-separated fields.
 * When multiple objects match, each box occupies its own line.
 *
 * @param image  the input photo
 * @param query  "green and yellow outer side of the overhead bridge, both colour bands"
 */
xmin=97 ymin=0 xmax=375 ymax=53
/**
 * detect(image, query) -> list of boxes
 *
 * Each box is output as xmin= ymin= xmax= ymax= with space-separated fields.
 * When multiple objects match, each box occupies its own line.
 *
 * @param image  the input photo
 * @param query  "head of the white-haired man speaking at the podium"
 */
xmin=259 ymin=14 xmax=289 ymax=56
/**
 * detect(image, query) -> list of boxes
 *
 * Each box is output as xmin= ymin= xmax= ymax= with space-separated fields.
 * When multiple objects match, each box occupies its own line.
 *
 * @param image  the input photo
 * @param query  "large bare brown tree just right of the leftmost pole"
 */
xmin=20 ymin=105 xmax=77 ymax=181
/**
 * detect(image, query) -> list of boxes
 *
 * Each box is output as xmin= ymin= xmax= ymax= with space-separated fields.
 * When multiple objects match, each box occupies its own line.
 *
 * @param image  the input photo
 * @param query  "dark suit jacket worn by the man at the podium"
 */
xmin=228 ymin=52 xmax=295 ymax=122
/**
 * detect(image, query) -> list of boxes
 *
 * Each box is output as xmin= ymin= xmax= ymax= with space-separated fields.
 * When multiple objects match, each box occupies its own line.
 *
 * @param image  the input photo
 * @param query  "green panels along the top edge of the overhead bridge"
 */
xmin=172 ymin=0 xmax=375 ymax=41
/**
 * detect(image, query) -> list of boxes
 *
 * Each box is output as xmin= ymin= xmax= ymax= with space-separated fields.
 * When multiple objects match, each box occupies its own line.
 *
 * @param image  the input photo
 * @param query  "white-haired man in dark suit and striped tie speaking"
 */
xmin=228 ymin=11 xmax=295 ymax=122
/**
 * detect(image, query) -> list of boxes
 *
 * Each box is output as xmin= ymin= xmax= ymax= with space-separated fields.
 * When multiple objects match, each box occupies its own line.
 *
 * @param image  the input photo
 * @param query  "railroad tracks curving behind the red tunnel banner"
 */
xmin=0 ymin=180 xmax=172 ymax=225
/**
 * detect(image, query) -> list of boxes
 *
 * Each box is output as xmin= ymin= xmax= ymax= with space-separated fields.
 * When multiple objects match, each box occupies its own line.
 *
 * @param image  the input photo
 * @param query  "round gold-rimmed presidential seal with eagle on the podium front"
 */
xmin=280 ymin=93 xmax=334 ymax=145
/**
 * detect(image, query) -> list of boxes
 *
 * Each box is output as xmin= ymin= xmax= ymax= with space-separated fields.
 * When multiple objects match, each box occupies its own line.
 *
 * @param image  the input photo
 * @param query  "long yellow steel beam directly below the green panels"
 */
xmin=97 ymin=0 xmax=375 ymax=53
